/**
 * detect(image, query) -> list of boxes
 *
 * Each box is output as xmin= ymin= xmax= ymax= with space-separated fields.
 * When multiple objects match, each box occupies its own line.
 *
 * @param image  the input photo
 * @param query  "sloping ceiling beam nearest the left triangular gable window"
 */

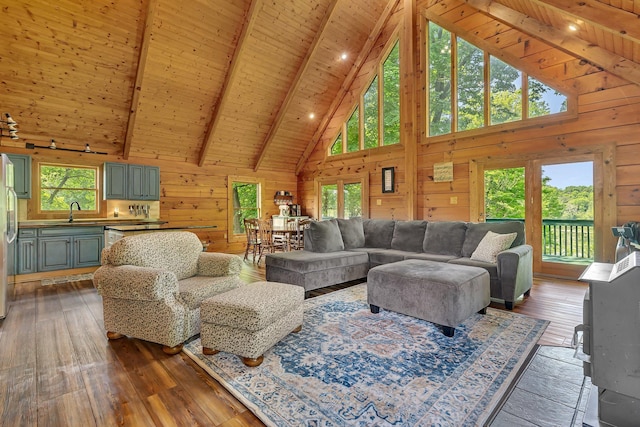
xmin=296 ymin=0 xmax=400 ymax=175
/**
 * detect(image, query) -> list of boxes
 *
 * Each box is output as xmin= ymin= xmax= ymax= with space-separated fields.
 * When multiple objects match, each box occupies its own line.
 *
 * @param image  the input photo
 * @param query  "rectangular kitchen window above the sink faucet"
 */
xmin=36 ymin=163 xmax=100 ymax=218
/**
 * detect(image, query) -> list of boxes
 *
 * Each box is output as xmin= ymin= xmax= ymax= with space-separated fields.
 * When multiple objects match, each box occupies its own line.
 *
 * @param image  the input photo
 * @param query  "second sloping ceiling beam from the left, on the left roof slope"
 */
xmin=198 ymin=0 xmax=262 ymax=166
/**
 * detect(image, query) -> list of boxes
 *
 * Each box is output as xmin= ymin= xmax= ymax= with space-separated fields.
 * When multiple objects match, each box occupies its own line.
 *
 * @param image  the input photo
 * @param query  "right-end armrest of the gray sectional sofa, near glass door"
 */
xmin=498 ymin=245 xmax=533 ymax=302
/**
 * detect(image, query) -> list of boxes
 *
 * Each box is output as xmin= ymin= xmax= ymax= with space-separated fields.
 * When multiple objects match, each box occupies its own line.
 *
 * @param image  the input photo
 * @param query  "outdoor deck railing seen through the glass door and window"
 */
xmin=487 ymin=218 xmax=595 ymax=261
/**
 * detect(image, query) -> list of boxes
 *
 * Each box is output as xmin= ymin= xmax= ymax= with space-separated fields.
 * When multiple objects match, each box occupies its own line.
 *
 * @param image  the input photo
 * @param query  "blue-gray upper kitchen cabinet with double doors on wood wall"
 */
xmin=104 ymin=163 xmax=160 ymax=200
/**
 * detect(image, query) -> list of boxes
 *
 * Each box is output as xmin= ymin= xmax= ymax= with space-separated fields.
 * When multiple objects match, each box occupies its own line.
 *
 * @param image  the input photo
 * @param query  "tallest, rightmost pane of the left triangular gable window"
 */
xmin=382 ymin=42 xmax=400 ymax=145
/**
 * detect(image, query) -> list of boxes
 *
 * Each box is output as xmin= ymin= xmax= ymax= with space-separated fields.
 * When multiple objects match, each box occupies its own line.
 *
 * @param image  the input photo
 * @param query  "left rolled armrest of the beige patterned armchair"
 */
xmin=93 ymin=265 xmax=178 ymax=301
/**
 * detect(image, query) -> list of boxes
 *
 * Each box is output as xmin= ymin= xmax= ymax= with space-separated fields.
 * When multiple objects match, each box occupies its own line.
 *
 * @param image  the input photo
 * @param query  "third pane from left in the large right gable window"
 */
xmin=490 ymin=56 xmax=522 ymax=125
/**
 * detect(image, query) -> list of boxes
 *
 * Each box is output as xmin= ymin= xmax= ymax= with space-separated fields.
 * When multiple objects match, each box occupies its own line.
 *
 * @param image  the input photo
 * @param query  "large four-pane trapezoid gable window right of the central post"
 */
xmin=425 ymin=21 xmax=574 ymax=137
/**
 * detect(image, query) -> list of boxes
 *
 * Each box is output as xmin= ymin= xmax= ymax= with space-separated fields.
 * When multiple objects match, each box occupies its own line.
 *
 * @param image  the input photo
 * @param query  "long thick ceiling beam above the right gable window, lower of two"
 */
xmin=463 ymin=0 xmax=640 ymax=84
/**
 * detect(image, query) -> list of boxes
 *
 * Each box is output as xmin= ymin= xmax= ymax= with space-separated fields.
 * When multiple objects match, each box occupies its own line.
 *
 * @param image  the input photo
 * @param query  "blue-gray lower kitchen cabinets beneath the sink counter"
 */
xmin=18 ymin=226 xmax=104 ymax=274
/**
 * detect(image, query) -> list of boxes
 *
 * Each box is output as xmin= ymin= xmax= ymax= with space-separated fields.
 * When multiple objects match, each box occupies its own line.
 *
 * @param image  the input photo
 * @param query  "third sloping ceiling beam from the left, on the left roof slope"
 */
xmin=253 ymin=0 xmax=338 ymax=171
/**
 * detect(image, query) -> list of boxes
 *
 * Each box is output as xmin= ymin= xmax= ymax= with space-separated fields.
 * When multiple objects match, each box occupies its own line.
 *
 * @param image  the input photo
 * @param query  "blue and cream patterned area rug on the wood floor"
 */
xmin=185 ymin=284 xmax=548 ymax=427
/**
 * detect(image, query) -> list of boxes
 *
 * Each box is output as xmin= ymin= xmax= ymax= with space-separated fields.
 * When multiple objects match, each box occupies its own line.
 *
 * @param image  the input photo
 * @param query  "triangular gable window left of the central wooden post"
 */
xmin=329 ymin=40 xmax=400 ymax=156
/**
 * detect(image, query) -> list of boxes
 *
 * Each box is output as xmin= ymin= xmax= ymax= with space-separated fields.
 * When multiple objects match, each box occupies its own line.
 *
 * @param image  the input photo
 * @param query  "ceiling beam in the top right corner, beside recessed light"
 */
xmin=529 ymin=0 xmax=640 ymax=43
